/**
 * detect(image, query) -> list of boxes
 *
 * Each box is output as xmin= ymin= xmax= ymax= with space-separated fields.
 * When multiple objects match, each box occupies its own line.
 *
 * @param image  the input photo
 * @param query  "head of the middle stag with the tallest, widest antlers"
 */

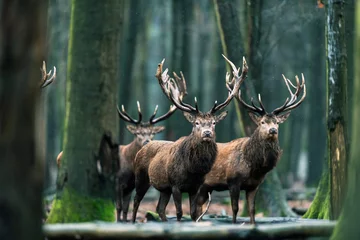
xmin=155 ymin=55 xmax=248 ymax=141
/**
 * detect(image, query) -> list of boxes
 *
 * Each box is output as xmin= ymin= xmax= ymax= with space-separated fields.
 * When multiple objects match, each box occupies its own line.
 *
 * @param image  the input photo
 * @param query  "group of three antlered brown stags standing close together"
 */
xmin=45 ymin=53 xmax=306 ymax=224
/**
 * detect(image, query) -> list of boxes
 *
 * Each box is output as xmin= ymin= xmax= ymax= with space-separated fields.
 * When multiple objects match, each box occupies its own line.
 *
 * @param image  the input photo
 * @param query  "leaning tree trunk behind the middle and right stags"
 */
xmin=214 ymin=0 xmax=295 ymax=216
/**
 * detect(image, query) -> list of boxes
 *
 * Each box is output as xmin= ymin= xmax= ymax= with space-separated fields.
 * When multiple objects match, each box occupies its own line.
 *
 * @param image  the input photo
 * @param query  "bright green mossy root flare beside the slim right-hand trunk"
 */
xmin=303 ymin=171 xmax=330 ymax=219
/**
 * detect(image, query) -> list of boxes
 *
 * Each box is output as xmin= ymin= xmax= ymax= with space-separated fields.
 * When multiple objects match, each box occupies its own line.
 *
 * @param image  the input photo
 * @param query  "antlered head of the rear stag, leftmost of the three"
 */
xmin=117 ymin=102 xmax=176 ymax=146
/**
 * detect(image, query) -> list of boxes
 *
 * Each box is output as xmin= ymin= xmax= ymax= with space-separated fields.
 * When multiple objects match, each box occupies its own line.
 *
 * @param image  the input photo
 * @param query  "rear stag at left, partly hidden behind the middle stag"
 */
xmin=116 ymin=98 xmax=186 ymax=221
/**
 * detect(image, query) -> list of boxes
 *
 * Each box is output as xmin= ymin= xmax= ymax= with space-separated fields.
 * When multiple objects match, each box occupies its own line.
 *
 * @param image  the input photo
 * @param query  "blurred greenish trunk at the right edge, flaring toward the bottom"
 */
xmin=331 ymin=1 xmax=360 ymax=237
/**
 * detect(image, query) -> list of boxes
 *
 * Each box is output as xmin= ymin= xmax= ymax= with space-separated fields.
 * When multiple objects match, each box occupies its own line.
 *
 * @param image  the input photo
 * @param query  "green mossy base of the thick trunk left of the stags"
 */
xmin=46 ymin=188 xmax=115 ymax=223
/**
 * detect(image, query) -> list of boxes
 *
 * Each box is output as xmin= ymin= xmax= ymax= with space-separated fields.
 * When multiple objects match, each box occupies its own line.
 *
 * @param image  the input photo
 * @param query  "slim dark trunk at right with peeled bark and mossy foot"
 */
xmin=304 ymin=0 xmax=348 ymax=219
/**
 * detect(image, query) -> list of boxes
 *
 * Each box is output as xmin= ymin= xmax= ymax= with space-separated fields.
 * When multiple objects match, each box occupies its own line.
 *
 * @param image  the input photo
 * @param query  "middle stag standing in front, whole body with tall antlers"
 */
xmin=132 ymin=56 xmax=247 ymax=222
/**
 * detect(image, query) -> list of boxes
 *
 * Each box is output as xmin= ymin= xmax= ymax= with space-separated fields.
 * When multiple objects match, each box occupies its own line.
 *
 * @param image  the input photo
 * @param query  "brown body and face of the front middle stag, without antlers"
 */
xmin=133 ymin=112 xmax=227 ymax=222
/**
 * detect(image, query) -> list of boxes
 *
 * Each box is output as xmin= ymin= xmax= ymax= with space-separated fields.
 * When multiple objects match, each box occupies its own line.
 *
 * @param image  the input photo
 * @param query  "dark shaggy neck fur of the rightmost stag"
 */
xmin=244 ymin=129 xmax=281 ymax=173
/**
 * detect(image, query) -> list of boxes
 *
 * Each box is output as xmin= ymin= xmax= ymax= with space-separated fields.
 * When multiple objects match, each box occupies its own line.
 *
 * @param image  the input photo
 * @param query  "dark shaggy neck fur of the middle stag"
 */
xmin=176 ymin=134 xmax=217 ymax=175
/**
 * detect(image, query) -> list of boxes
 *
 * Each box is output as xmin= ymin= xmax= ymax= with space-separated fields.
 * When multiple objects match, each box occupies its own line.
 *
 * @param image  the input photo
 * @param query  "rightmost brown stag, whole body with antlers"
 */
xmin=196 ymin=72 xmax=306 ymax=224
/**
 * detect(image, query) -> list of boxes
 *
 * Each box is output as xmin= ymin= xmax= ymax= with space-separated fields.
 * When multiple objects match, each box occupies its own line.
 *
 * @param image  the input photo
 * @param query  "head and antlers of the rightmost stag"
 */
xmin=237 ymin=74 xmax=306 ymax=140
